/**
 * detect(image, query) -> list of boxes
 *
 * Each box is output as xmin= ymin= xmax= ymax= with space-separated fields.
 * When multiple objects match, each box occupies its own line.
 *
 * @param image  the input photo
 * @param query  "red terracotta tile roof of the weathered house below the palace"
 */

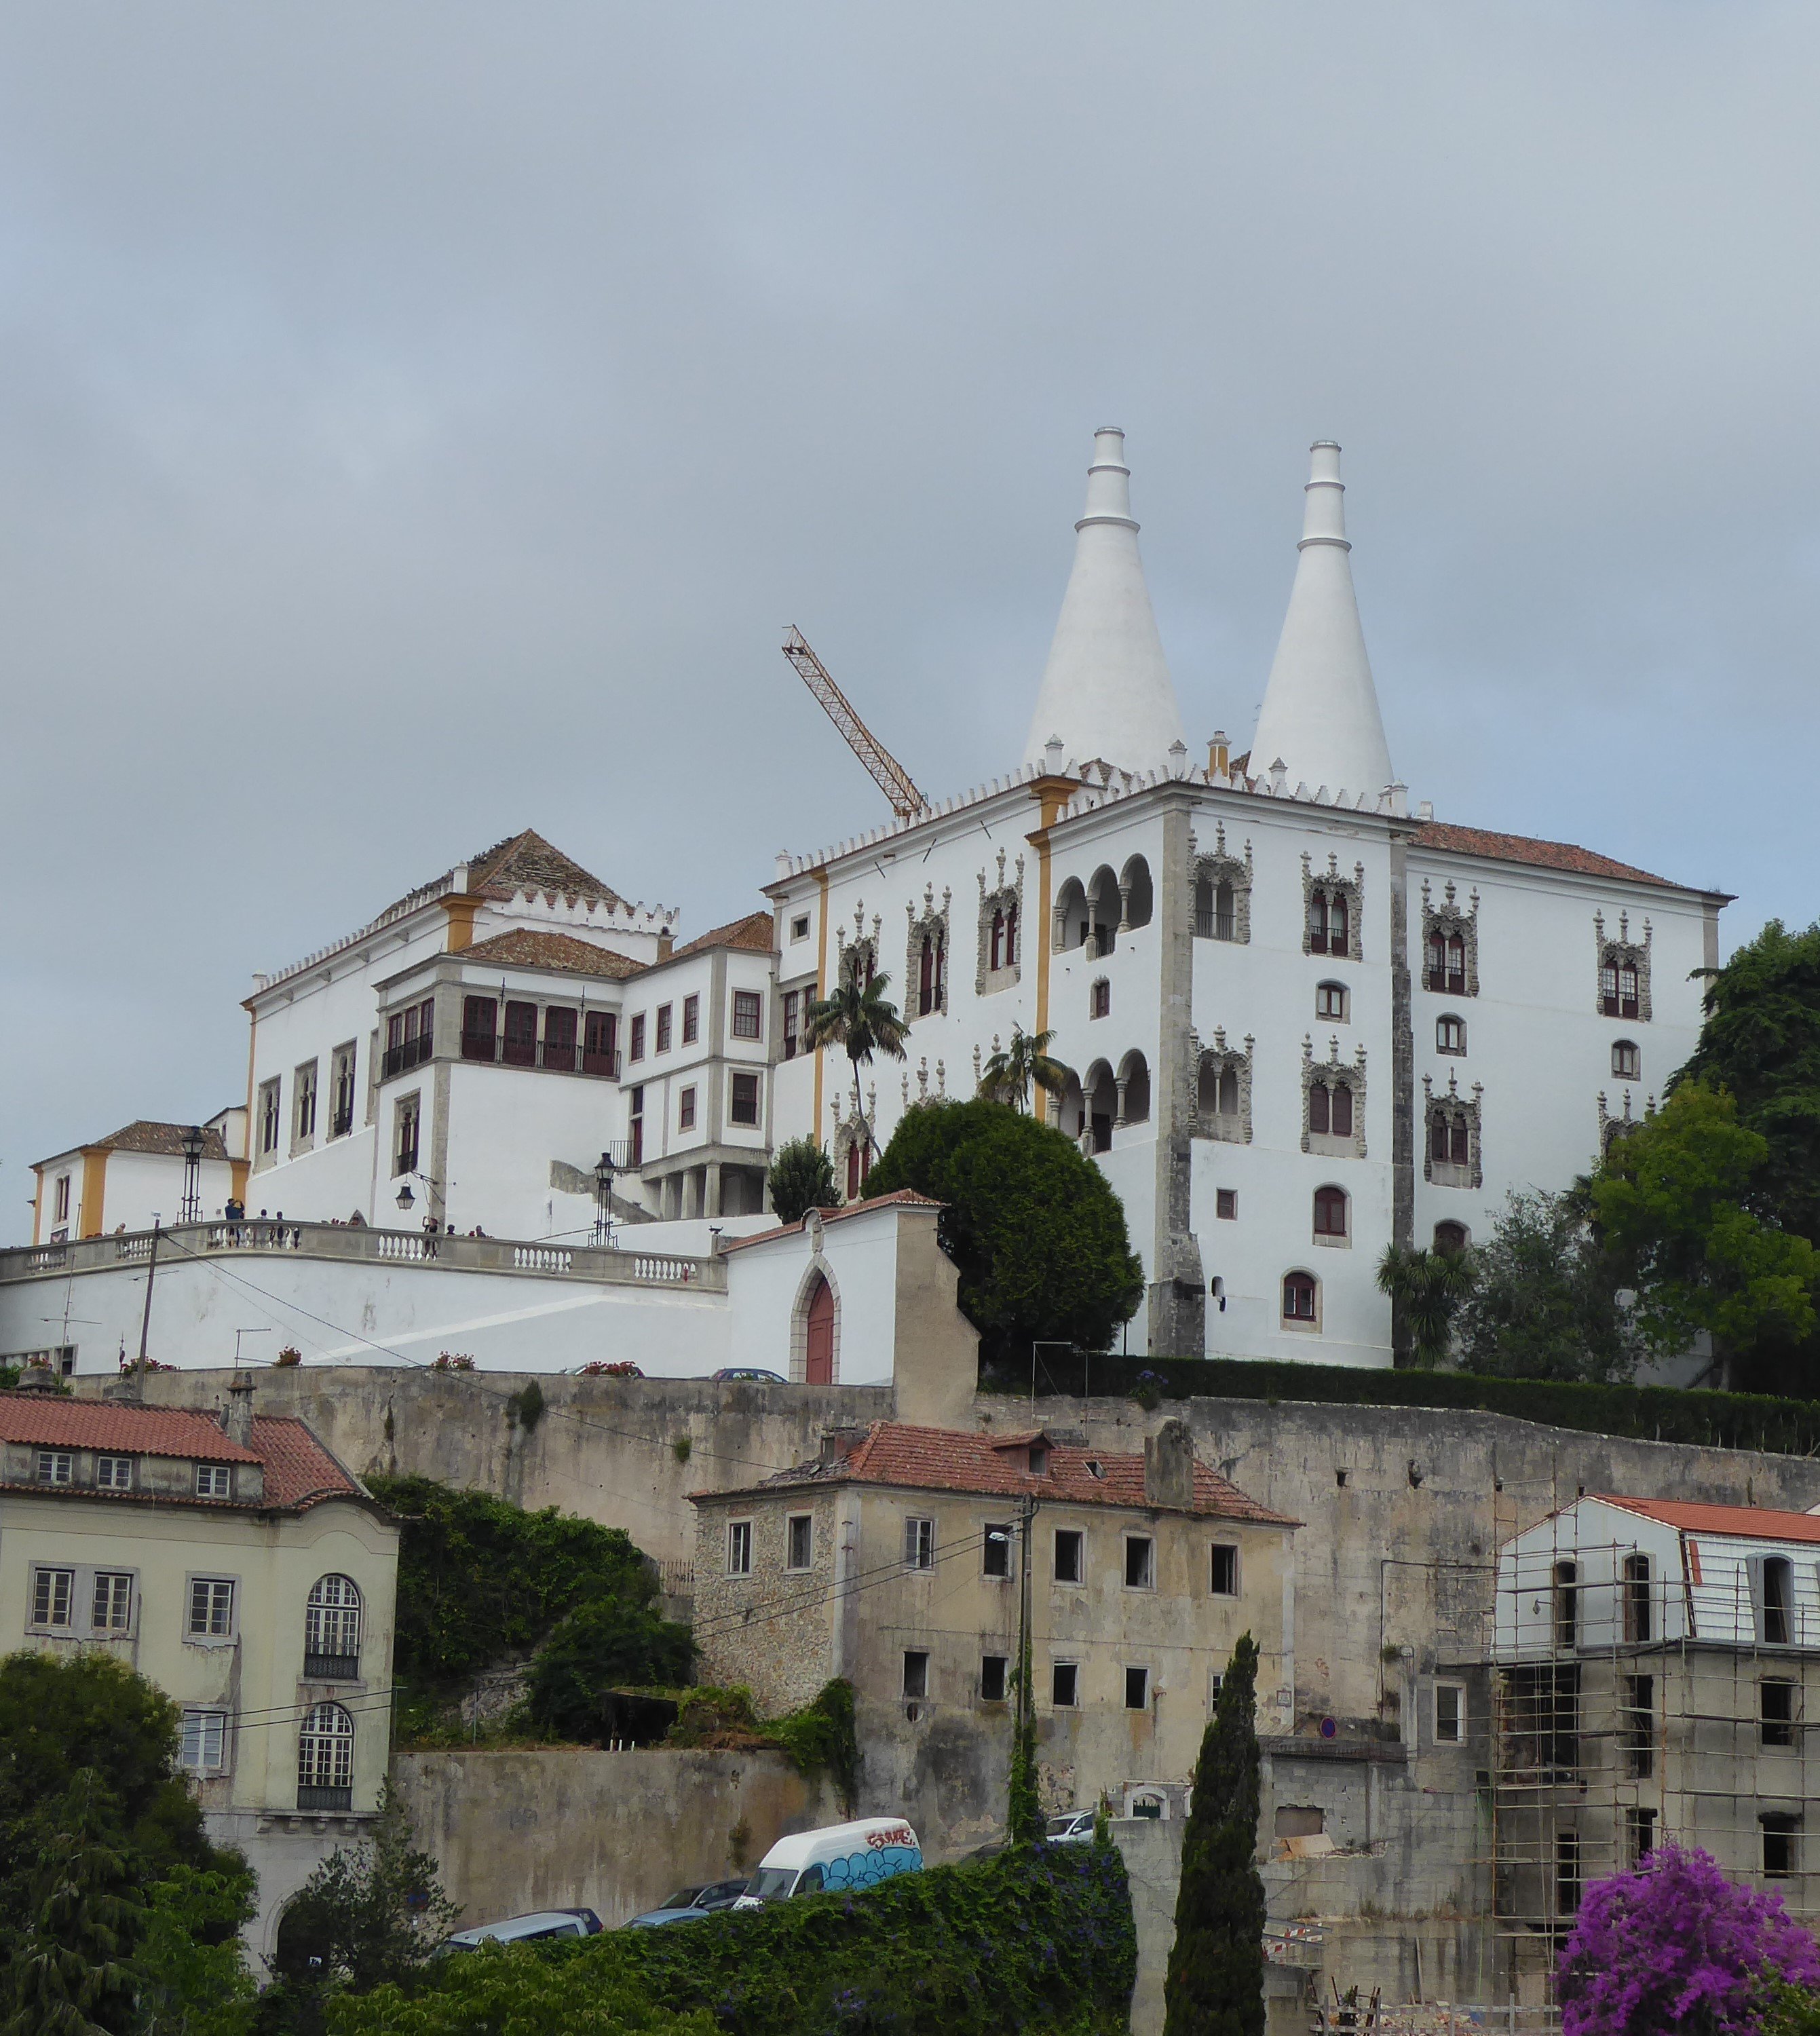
xmin=690 ymin=1421 xmax=1301 ymax=1527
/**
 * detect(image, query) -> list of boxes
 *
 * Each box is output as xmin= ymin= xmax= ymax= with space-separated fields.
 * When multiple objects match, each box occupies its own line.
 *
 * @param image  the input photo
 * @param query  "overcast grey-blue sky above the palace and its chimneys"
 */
xmin=0 ymin=0 xmax=1820 ymax=1238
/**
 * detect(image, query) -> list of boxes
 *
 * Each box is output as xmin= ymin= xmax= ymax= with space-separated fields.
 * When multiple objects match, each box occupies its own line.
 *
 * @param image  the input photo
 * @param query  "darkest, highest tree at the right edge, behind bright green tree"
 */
xmin=1677 ymin=918 xmax=1820 ymax=1244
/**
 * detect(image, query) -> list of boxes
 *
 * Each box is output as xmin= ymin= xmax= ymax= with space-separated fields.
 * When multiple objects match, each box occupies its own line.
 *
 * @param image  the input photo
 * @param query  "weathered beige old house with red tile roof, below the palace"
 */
xmin=694 ymin=1421 xmax=1297 ymax=1853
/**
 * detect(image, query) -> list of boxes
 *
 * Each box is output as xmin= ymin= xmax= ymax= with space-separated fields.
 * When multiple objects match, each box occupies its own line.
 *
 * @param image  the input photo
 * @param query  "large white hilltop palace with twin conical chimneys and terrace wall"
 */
xmin=0 ymin=430 xmax=1726 ymax=1378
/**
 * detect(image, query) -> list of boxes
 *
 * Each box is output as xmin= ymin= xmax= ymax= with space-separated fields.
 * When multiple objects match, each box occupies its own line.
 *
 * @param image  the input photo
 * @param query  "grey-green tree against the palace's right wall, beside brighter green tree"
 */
xmin=1456 ymin=1189 xmax=1643 ymax=1384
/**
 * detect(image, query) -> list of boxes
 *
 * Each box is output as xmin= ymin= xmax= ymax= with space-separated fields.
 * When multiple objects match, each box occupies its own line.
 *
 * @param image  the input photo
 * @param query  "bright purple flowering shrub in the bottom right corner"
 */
xmin=1557 ymin=1845 xmax=1820 ymax=2036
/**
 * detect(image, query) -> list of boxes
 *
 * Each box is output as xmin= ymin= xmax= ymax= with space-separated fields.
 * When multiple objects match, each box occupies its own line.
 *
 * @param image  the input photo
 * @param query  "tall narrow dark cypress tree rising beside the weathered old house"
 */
xmin=1162 ymin=1633 xmax=1264 ymax=2036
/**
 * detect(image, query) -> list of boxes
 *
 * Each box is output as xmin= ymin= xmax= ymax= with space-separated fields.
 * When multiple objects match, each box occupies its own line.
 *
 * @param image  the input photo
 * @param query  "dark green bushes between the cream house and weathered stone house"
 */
xmin=366 ymin=1476 xmax=658 ymax=1688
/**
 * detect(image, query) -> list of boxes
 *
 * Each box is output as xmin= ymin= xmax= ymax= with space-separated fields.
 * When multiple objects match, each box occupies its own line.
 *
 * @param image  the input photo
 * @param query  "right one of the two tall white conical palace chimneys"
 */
xmin=1250 ymin=440 xmax=1392 ymax=798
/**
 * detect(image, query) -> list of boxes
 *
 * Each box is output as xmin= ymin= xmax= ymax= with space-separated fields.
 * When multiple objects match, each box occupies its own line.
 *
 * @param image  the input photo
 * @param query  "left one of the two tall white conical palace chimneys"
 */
xmin=1024 ymin=428 xmax=1183 ymax=770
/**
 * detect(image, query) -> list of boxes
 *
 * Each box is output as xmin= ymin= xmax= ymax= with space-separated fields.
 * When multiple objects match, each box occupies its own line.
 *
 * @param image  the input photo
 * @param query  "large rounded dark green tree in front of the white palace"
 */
xmin=867 ymin=1101 xmax=1144 ymax=1358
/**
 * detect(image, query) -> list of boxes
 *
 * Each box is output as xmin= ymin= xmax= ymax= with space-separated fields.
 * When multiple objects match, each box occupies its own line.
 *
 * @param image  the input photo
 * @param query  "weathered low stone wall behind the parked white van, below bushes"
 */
xmin=395 ymin=1747 xmax=841 ymax=1930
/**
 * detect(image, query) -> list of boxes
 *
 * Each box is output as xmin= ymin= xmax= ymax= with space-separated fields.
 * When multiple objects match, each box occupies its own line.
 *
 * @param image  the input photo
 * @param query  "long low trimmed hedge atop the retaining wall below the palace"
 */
xmin=979 ymin=1350 xmax=1820 ymax=1456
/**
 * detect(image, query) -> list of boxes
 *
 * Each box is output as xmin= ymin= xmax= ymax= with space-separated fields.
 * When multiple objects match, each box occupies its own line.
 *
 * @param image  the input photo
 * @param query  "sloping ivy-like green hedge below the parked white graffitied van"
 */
xmin=330 ymin=1845 xmax=1138 ymax=2036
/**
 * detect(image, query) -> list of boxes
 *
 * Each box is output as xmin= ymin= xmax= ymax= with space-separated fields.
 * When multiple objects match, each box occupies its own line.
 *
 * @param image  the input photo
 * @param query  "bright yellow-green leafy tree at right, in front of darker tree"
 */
xmin=1588 ymin=1081 xmax=1820 ymax=1391
